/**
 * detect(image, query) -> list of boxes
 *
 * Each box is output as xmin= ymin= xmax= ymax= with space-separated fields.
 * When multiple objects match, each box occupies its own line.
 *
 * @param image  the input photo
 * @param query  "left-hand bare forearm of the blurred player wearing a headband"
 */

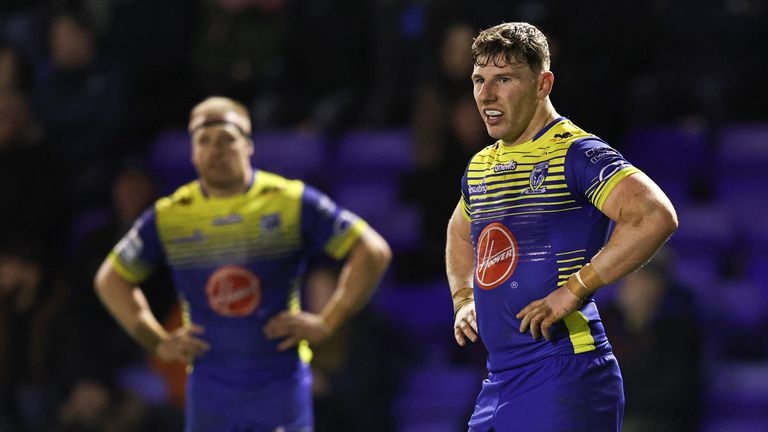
xmin=94 ymin=263 xmax=168 ymax=353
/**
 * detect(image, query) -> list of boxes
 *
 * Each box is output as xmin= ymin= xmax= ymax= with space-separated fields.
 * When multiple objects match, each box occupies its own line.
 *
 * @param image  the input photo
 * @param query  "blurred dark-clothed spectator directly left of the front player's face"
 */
xmin=402 ymin=22 xmax=486 ymax=279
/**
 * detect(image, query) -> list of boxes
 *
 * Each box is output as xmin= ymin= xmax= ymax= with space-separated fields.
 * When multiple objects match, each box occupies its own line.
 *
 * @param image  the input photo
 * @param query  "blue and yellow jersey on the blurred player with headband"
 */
xmin=109 ymin=171 xmax=367 ymax=376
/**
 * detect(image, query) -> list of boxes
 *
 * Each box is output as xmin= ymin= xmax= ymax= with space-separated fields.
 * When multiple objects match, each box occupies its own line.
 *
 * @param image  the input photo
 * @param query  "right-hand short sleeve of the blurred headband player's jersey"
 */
xmin=301 ymin=185 xmax=368 ymax=259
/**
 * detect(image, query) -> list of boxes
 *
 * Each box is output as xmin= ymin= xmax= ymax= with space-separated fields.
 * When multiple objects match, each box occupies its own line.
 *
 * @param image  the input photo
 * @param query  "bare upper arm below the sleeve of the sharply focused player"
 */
xmin=600 ymin=172 xmax=674 ymax=222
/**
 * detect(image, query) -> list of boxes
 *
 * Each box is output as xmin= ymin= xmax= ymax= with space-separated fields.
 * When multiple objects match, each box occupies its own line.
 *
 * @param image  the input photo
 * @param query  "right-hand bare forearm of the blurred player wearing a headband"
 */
xmin=320 ymin=229 xmax=392 ymax=331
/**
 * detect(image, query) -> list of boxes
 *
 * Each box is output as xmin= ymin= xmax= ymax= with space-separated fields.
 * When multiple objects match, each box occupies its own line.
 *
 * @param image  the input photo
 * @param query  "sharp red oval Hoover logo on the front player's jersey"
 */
xmin=475 ymin=222 xmax=519 ymax=290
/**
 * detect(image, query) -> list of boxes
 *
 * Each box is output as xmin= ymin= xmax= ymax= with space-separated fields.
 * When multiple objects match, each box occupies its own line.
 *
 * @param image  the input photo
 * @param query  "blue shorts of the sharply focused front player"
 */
xmin=469 ymin=351 xmax=624 ymax=432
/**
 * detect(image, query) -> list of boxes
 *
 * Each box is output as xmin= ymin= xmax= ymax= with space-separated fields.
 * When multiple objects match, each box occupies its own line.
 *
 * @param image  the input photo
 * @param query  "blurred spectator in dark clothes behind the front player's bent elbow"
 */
xmin=601 ymin=254 xmax=703 ymax=432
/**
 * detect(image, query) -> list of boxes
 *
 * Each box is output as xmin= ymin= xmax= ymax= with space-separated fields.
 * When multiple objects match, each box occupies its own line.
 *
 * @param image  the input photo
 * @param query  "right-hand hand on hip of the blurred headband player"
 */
xmin=262 ymin=311 xmax=331 ymax=351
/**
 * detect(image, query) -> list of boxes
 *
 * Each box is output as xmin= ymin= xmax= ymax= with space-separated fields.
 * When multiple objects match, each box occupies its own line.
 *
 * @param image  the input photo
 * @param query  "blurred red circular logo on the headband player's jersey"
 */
xmin=205 ymin=266 xmax=261 ymax=317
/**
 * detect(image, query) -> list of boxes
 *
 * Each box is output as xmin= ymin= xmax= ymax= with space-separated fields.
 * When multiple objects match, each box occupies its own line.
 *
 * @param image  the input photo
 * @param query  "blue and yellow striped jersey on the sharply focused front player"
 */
xmin=461 ymin=117 xmax=639 ymax=372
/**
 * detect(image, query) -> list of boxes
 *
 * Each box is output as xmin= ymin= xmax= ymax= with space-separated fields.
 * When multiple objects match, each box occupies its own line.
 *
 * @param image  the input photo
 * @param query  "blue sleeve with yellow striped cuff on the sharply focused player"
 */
xmin=565 ymin=138 xmax=640 ymax=210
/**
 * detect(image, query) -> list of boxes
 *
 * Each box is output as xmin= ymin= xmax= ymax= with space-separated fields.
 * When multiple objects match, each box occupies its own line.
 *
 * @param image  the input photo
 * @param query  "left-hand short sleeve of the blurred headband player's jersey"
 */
xmin=109 ymin=207 xmax=165 ymax=283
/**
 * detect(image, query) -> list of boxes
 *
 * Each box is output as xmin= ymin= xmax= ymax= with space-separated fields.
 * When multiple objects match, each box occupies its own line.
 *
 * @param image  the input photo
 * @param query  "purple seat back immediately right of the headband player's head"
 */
xmin=253 ymin=130 xmax=330 ymax=181
